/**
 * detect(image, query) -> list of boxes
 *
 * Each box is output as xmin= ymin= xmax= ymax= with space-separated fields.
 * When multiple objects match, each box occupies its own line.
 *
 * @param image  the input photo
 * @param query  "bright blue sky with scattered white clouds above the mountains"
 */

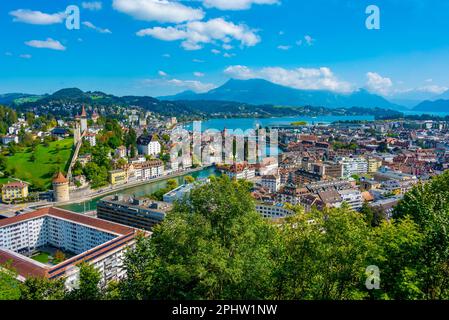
xmin=0 ymin=0 xmax=449 ymax=99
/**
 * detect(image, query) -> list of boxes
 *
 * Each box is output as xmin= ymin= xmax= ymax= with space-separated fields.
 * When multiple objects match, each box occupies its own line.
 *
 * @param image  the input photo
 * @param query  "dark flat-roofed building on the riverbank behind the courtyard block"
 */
xmin=97 ymin=195 xmax=173 ymax=230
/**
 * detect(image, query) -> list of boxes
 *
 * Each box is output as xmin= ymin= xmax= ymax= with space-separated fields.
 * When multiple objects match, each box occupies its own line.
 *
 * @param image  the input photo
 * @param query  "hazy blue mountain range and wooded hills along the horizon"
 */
xmin=0 ymin=79 xmax=449 ymax=116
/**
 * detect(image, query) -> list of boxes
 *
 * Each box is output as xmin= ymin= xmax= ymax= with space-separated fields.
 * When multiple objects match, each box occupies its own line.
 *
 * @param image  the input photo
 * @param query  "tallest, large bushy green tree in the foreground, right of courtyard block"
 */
xmin=126 ymin=177 xmax=274 ymax=300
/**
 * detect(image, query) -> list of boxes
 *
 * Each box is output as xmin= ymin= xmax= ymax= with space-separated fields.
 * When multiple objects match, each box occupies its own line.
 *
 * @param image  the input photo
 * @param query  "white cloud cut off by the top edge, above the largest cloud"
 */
xmin=112 ymin=0 xmax=205 ymax=23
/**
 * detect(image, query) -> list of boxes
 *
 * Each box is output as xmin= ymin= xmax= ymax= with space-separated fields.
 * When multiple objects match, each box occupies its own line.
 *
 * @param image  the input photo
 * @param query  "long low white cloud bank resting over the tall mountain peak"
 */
xmin=224 ymin=65 xmax=353 ymax=92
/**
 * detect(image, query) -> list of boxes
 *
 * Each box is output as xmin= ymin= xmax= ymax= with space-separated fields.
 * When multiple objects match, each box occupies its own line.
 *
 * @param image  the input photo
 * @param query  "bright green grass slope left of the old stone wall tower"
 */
xmin=0 ymin=138 xmax=73 ymax=188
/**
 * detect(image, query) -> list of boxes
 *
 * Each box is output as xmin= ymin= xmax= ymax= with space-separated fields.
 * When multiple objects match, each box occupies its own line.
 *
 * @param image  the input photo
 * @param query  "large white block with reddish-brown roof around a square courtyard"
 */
xmin=0 ymin=207 xmax=138 ymax=289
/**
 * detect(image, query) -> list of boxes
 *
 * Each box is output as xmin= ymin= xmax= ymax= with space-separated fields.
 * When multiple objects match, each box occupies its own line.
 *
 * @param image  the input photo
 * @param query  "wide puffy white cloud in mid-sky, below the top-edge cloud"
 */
xmin=137 ymin=18 xmax=260 ymax=50
